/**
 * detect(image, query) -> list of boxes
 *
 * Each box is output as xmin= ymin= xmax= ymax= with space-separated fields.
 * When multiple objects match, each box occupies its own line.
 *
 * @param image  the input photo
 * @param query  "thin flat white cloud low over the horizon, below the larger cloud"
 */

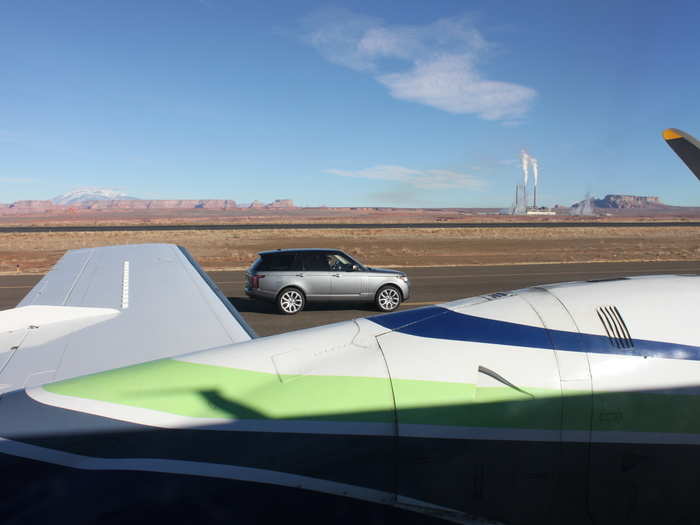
xmin=326 ymin=165 xmax=483 ymax=190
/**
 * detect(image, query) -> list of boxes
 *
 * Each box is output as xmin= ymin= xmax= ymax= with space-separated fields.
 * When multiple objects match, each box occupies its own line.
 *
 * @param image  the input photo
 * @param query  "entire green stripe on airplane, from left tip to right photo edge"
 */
xmin=44 ymin=359 xmax=700 ymax=434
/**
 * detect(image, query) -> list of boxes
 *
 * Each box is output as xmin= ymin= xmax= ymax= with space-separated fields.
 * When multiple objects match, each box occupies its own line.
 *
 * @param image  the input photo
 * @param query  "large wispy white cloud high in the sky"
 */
xmin=307 ymin=9 xmax=536 ymax=123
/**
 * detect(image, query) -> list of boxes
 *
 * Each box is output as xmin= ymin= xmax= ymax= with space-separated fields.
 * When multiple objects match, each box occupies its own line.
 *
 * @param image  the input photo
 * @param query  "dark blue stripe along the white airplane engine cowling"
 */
xmin=368 ymin=306 xmax=700 ymax=361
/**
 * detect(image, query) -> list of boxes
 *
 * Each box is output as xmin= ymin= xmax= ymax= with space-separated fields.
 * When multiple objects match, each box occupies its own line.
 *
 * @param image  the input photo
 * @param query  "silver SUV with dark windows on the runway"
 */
xmin=245 ymin=249 xmax=410 ymax=314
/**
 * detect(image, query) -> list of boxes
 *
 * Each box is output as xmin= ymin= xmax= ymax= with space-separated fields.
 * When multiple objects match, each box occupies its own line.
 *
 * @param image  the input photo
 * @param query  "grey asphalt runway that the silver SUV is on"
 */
xmin=0 ymin=262 xmax=700 ymax=336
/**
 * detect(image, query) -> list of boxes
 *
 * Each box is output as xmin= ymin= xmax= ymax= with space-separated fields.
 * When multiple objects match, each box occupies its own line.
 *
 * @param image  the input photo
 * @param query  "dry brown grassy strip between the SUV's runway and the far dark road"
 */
xmin=0 ymin=227 xmax=700 ymax=273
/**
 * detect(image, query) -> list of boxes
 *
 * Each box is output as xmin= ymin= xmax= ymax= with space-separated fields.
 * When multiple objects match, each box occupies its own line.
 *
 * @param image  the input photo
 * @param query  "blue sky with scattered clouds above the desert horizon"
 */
xmin=0 ymin=0 xmax=700 ymax=207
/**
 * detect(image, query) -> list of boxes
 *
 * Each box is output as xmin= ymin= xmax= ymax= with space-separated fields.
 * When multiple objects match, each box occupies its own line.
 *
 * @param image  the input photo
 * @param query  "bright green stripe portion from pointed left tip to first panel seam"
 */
xmin=44 ymin=359 xmax=394 ymax=422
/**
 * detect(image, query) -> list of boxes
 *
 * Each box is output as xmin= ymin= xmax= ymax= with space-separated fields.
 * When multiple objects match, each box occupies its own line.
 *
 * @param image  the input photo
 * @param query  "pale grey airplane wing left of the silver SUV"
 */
xmin=0 ymin=244 xmax=255 ymax=392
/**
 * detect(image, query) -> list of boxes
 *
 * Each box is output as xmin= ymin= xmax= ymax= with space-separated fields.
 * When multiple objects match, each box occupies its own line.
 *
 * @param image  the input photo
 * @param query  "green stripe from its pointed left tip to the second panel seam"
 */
xmin=44 ymin=359 xmax=561 ymax=429
